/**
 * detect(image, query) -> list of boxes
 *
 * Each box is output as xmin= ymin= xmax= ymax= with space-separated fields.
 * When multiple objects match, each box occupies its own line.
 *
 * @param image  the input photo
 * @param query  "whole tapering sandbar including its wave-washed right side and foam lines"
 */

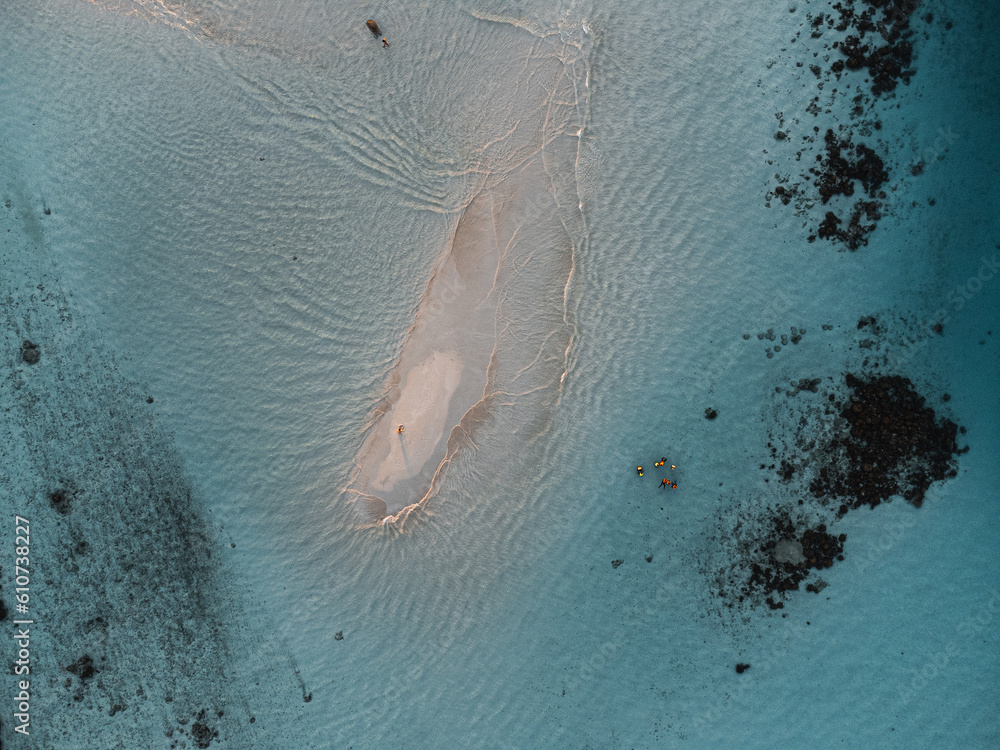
xmin=348 ymin=17 xmax=585 ymax=523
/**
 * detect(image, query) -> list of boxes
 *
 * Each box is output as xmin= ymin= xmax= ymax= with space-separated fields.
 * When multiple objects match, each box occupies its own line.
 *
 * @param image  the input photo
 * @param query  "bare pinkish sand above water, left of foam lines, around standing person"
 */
xmin=351 ymin=182 xmax=502 ymax=519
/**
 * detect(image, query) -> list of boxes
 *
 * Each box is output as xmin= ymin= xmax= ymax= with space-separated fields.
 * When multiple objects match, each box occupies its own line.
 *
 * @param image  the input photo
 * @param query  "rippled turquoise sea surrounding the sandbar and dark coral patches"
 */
xmin=0 ymin=2 xmax=1000 ymax=748
